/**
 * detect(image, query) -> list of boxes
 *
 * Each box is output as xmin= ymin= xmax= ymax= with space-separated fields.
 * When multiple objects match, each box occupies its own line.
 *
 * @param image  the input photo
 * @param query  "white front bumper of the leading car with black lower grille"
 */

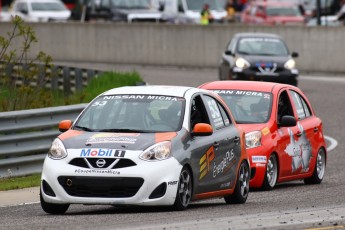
xmin=41 ymin=157 xmax=182 ymax=206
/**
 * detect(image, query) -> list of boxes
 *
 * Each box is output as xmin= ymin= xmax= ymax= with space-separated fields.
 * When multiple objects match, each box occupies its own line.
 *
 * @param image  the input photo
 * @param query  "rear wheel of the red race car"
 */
xmin=304 ymin=149 xmax=326 ymax=184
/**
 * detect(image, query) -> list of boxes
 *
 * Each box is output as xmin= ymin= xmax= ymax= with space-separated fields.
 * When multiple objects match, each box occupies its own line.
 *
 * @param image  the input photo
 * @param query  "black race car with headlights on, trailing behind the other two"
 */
xmin=219 ymin=33 xmax=299 ymax=85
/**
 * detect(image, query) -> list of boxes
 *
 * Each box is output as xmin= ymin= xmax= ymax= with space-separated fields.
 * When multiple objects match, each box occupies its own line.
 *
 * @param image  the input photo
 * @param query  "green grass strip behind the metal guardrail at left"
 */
xmin=0 ymin=72 xmax=143 ymax=112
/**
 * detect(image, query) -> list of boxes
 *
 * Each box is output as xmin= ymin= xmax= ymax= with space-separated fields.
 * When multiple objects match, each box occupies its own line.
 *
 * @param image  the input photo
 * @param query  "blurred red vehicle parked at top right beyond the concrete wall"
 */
xmin=241 ymin=1 xmax=305 ymax=25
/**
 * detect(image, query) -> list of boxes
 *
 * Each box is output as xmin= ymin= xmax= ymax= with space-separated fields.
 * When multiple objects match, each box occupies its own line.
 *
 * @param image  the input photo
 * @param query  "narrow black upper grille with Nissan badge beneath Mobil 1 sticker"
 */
xmin=69 ymin=158 xmax=136 ymax=169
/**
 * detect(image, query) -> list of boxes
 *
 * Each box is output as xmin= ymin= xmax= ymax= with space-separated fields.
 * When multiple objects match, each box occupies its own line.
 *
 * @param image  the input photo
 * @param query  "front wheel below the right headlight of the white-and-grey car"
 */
xmin=173 ymin=167 xmax=193 ymax=211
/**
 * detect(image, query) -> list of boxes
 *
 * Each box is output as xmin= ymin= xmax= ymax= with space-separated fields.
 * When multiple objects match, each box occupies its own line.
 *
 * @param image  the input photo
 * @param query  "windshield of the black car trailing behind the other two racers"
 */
xmin=237 ymin=38 xmax=289 ymax=56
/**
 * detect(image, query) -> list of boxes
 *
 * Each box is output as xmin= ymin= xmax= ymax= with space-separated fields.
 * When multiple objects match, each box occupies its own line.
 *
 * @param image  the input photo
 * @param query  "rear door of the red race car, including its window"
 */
xmin=289 ymin=90 xmax=322 ymax=174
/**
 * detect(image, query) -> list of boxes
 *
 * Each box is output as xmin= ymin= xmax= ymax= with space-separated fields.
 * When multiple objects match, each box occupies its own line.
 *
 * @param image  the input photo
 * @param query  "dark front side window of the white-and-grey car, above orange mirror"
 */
xmin=190 ymin=95 xmax=210 ymax=130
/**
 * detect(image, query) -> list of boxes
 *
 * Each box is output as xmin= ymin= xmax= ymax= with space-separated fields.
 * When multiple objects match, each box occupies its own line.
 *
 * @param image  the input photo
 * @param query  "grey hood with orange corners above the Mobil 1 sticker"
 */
xmin=59 ymin=130 xmax=177 ymax=151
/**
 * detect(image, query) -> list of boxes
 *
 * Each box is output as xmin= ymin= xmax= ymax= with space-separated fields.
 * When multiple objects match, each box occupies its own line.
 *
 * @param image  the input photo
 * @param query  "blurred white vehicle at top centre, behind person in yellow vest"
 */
xmin=160 ymin=0 xmax=226 ymax=24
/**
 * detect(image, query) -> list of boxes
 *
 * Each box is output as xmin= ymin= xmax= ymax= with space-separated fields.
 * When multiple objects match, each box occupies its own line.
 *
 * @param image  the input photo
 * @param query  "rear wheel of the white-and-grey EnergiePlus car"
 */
xmin=224 ymin=161 xmax=250 ymax=204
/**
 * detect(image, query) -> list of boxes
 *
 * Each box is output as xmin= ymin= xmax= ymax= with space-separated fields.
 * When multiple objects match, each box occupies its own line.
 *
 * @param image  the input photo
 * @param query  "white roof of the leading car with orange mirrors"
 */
xmin=103 ymin=85 xmax=195 ymax=97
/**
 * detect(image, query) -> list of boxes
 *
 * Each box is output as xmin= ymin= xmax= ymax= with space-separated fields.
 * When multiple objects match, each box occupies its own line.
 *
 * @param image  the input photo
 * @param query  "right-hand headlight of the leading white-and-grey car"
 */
xmin=140 ymin=141 xmax=171 ymax=161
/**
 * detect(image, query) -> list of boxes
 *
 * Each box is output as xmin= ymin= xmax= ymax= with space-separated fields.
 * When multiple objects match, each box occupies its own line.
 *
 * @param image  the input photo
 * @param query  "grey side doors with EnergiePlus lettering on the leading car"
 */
xmin=191 ymin=95 xmax=241 ymax=195
